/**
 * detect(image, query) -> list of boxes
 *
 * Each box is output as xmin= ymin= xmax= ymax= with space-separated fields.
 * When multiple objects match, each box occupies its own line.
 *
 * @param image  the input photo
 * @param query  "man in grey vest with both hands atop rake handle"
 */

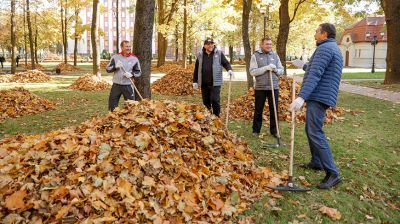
xmin=250 ymin=37 xmax=284 ymax=138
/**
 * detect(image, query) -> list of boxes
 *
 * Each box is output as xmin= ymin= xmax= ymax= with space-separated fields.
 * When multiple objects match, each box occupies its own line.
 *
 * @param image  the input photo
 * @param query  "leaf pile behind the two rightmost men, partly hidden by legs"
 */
xmin=230 ymin=77 xmax=345 ymax=123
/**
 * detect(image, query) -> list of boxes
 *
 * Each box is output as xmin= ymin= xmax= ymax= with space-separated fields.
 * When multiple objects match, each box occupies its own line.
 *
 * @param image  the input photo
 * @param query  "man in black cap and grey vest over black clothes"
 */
xmin=193 ymin=38 xmax=233 ymax=117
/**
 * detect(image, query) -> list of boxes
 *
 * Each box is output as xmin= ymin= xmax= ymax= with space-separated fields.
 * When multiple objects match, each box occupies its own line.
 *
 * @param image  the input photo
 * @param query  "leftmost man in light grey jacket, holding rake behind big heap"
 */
xmin=106 ymin=40 xmax=141 ymax=111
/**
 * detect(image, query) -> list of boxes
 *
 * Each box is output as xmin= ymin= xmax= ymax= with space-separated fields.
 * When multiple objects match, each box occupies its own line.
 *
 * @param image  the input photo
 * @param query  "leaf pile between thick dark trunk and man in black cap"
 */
xmin=151 ymin=68 xmax=200 ymax=96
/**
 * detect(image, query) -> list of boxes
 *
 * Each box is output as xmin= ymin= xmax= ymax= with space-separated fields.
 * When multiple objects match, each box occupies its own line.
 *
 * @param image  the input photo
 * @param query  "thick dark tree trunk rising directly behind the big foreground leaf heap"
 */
xmin=133 ymin=0 xmax=155 ymax=99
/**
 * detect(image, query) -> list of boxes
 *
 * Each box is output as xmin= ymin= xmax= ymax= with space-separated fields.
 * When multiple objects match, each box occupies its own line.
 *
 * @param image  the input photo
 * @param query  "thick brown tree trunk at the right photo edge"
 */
xmin=378 ymin=0 xmax=400 ymax=84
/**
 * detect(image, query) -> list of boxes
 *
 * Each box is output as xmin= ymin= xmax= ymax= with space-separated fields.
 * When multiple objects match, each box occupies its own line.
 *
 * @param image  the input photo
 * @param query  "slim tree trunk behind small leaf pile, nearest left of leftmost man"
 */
xmin=90 ymin=0 xmax=101 ymax=77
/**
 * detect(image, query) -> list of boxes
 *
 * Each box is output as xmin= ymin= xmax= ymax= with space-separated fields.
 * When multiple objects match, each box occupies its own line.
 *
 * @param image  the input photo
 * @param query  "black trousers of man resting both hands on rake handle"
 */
xmin=253 ymin=89 xmax=279 ymax=135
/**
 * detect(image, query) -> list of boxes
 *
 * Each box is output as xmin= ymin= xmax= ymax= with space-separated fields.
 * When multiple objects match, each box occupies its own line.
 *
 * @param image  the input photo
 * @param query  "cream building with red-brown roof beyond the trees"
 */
xmin=339 ymin=16 xmax=387 ymax=68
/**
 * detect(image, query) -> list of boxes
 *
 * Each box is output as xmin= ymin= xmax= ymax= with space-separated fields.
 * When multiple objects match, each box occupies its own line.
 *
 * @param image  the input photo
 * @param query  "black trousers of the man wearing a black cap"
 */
xmin=201 ymin=86 xmax=221 ymax=117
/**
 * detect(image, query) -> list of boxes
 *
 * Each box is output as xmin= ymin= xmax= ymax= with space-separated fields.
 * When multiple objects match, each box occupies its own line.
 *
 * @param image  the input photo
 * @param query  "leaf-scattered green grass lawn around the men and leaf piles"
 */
xmin=0 ymin=73 xmax=400 ymax=223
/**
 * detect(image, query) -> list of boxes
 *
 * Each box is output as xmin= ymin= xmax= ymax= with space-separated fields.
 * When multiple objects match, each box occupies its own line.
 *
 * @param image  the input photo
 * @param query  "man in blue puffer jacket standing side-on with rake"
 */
xmin=290 ymin=23 xmax=343 ymax=189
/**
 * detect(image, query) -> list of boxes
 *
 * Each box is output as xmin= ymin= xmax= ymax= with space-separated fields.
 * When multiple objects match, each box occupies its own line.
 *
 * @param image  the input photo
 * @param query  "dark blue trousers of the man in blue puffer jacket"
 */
xmin=306 ymin=101 xmax=339 ymax=175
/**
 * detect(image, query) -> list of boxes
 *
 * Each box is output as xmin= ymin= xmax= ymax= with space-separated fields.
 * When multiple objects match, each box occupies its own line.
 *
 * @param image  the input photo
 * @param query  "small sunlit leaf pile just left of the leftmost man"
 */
xmin=69 ymin=74 xmax=111 ymax=91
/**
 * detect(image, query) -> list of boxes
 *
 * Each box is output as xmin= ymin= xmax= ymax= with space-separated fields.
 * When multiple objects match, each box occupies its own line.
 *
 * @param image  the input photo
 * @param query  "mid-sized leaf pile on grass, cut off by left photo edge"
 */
xmin=0 ymin=87 xmax=54 ymax=122
